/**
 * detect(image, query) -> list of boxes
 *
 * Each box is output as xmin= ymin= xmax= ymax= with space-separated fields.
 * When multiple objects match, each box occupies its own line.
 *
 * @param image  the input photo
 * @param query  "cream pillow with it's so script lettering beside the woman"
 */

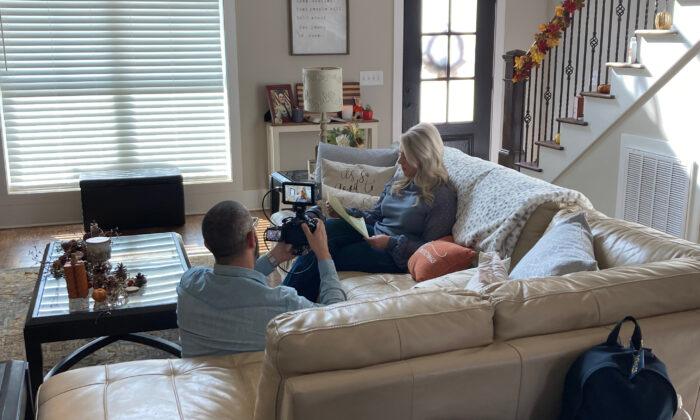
xmin=321 ymin=159 xmax=396 ymax=196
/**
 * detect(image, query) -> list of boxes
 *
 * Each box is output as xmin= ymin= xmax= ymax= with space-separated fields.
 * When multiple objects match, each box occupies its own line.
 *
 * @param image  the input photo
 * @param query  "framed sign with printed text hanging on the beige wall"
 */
xmin=289 ymin=0 xmax=350 ymax=55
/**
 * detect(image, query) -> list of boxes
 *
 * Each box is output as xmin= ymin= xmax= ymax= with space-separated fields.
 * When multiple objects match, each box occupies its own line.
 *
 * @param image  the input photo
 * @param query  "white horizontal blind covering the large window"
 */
xmin=0 ymin=0 xmax=231 ymax=193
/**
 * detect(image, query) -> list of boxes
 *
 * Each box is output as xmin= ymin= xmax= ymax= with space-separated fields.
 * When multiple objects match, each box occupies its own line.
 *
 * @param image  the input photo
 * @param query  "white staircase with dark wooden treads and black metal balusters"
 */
xmin=499 ymin=0 xmax=700 ymax=183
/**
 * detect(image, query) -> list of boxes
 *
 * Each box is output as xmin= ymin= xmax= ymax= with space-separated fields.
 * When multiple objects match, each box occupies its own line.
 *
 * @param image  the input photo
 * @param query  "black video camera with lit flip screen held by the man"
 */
xmin=265 ymin=182 xmax=316 ymax=255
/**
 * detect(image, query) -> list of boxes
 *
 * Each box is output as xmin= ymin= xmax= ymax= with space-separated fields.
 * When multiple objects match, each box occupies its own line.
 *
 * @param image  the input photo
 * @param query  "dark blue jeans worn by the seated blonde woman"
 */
xmin=282 ymin=219 xmax=404 ymax=302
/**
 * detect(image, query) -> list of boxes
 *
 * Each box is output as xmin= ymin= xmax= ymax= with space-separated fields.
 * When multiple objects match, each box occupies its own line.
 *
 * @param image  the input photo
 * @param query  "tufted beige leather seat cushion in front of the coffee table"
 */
xmin=37 ymin=352 xmax=263 ymax=420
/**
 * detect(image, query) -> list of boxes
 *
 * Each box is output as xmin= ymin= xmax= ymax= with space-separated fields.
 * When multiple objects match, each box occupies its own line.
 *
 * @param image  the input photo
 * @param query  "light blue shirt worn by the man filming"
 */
xmin=177 ymin=256 xmax=346 ymax=357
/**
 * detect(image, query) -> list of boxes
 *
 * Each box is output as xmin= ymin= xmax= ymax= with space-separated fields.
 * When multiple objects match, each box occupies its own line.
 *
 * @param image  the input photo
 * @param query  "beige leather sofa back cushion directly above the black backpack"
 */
xmin=490 ymin=258 xmax=700 ymax=340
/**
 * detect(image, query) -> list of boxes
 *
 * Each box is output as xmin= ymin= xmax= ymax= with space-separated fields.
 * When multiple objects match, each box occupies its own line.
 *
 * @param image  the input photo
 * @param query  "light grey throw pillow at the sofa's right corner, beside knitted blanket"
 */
xmin=510 ymin=212 xmax=598 ymax=280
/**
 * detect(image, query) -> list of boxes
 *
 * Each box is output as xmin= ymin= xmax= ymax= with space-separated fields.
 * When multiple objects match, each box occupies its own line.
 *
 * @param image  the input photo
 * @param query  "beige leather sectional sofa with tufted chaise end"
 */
xmin=38 ymin=208 xmax=700 ymax=420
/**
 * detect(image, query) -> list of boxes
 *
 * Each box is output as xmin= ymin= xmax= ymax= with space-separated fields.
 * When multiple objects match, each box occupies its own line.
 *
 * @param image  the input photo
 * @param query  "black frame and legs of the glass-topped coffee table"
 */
xmin=24 ymin=235 xmax=190 ymax=395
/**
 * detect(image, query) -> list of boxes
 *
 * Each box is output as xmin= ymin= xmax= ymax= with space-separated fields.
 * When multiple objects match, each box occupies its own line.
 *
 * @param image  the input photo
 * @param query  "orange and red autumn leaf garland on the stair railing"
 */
xmin=513 ymin=0 xmax=585 ymax=83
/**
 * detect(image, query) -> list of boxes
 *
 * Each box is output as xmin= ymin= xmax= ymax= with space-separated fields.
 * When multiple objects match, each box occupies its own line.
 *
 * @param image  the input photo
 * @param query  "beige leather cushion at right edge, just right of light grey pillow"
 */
xmin=588 ymin=211 xmax=700 ymax=268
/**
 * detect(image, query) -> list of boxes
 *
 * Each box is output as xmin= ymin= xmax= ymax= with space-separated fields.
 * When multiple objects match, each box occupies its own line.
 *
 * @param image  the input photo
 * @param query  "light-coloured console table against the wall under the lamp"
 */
xmin=267 ymin=120 xmax=379 ymax=173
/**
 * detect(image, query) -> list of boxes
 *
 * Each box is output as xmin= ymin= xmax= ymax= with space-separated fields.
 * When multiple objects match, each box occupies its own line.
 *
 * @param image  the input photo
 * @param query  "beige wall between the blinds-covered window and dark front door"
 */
xmin=236 ymin=0 xmax=394 ymax=189
